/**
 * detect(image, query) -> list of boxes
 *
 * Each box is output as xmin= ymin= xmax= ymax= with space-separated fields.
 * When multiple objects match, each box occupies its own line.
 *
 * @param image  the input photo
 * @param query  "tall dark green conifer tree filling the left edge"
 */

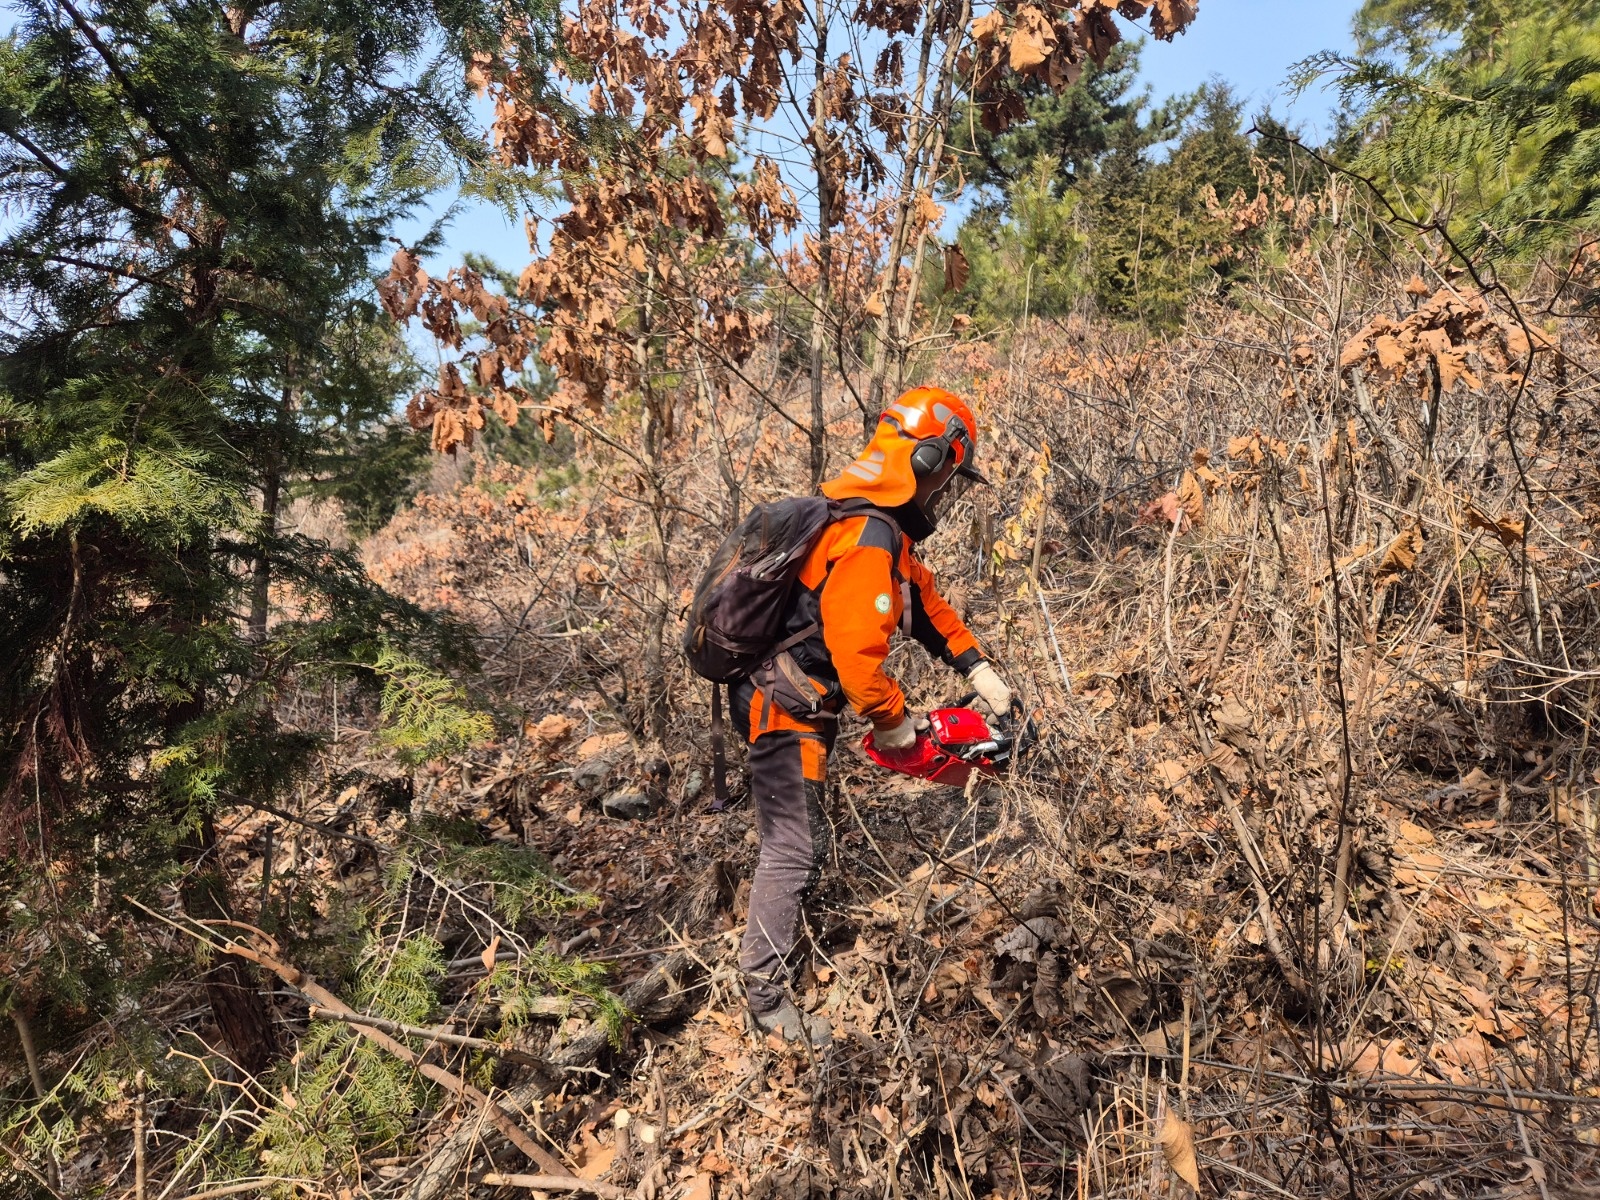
xmin=0 ymin=0 xmax=555 ymax=1088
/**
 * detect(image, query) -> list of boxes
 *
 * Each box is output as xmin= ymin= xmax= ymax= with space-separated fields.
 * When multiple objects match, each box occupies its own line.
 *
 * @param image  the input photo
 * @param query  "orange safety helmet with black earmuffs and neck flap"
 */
xmin=822 ymin=387 xmax=987 ymax=509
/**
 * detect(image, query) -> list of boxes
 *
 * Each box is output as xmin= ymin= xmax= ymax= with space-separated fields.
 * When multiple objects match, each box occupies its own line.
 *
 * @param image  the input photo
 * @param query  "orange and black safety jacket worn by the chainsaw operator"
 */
xmin=768 ymin=514 xmax=984 ymax=728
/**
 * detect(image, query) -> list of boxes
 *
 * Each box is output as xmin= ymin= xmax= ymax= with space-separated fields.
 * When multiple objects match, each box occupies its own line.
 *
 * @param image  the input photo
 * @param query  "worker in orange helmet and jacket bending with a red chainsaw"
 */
xmin=733 ymin=387 xmax=1011 ymax=1046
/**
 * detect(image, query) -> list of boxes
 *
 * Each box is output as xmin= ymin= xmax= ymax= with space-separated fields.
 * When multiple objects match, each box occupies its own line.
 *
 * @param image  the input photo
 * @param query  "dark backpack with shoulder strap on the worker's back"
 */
xmin=683 ymin=496 xmax=901 ymax=811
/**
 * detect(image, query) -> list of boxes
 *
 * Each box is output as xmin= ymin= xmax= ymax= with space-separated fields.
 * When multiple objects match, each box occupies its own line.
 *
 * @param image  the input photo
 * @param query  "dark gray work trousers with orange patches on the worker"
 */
xmin=733 ymin=688 xmax=837 ymax=1013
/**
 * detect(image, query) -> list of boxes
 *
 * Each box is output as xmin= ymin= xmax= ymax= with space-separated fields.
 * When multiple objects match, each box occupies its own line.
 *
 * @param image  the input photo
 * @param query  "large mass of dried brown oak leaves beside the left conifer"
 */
xmin=384 ymin=0 xmax=803 ymax=451
